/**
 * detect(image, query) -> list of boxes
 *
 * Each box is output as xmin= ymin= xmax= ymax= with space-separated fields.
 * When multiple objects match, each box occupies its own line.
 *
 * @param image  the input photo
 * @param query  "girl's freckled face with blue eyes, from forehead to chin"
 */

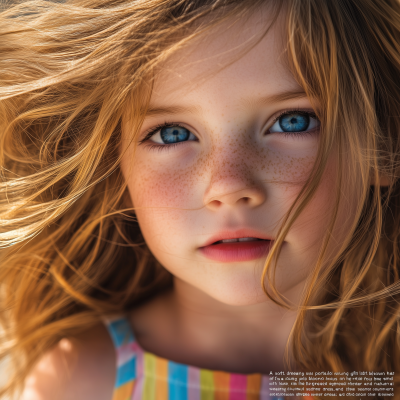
xmin=122 ymin=12 xmax=346 ymax=305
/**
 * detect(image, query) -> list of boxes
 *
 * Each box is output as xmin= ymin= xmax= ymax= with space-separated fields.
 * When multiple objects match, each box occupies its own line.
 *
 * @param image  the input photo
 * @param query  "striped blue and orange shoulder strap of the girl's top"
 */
xmin=103 ymin=316 xmax=136 ymax=399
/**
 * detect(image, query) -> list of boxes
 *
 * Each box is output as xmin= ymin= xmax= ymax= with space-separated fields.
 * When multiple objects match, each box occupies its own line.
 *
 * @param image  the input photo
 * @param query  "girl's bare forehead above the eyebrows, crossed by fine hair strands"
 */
xmin=150 ymin=7 xmax=301 ymax=108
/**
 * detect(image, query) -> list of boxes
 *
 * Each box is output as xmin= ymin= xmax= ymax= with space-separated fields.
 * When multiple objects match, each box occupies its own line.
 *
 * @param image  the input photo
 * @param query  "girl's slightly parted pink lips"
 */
xmin=199 ymin=229 xmax=273 ymax=262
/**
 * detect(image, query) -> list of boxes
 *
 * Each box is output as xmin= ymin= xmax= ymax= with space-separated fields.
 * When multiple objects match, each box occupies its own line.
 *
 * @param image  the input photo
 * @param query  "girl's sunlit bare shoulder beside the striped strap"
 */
xmin=21 ymin=324 xmax=116 ymax=400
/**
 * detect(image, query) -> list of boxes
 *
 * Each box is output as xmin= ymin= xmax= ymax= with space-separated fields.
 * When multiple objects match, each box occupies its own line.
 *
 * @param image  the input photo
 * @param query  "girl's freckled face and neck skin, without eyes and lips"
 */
xmin=122 ymin=10 xmax=354 ymax=373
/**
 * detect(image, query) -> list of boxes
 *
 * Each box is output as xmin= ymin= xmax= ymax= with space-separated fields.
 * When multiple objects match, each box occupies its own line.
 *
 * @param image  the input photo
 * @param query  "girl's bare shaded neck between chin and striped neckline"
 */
xmin=133 ymin=278 xmax=303 ymax=374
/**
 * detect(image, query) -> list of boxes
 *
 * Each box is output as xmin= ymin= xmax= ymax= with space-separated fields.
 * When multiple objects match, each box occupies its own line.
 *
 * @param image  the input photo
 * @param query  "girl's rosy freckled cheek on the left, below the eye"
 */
xmin=125 ymin=152 xmax=199 ymax=255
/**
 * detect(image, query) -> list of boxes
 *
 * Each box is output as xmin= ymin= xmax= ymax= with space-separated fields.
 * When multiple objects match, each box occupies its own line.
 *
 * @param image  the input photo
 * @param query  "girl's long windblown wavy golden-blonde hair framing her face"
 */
xmin=0 ymin=0 xmax=400 ymax=397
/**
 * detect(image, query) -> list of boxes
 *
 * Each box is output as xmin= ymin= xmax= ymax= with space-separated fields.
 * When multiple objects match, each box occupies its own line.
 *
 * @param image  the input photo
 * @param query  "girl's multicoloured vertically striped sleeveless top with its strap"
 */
xmin=105 ymin=316 xmax=312 ymax=400
